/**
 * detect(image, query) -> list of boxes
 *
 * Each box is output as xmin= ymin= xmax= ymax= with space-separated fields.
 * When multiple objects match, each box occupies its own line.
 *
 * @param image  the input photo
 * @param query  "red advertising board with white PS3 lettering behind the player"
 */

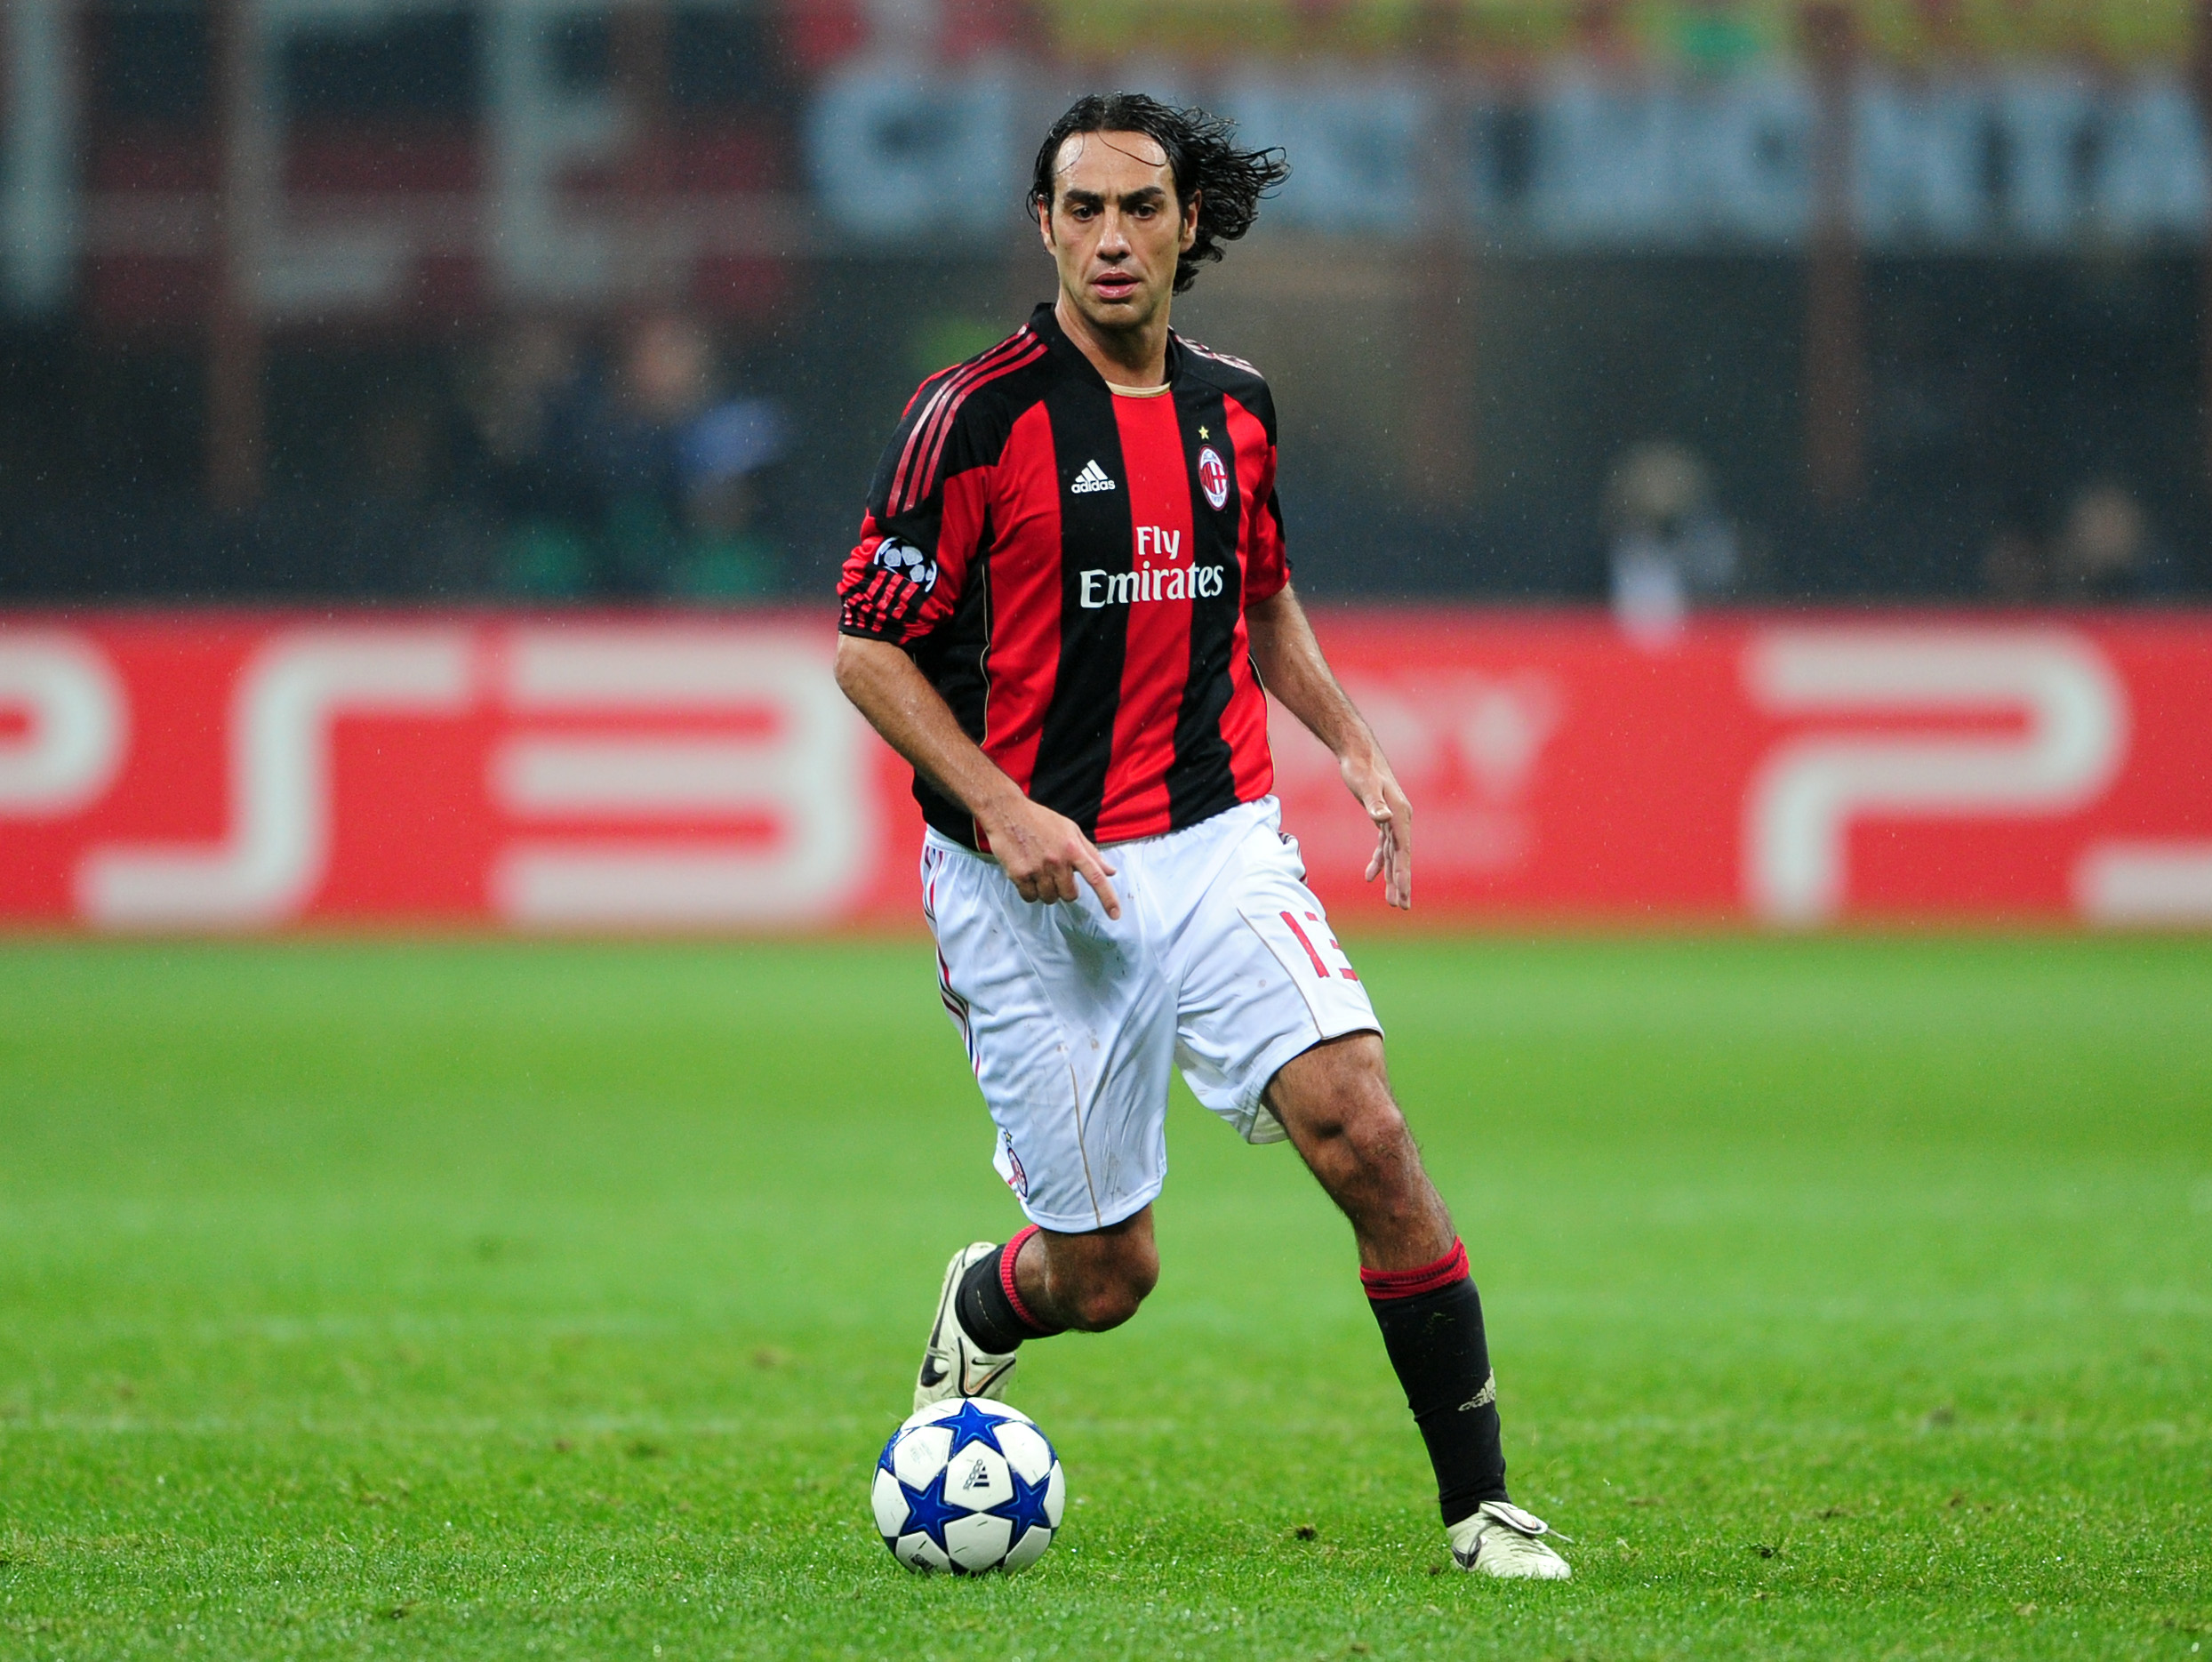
xmin=0 ymin=608 xmax=2212 ymax=932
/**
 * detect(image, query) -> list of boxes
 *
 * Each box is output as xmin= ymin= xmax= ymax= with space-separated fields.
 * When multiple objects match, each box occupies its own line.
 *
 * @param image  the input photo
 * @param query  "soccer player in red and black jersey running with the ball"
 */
xmin=836 ymin=93 xmax=1568 ymax=1578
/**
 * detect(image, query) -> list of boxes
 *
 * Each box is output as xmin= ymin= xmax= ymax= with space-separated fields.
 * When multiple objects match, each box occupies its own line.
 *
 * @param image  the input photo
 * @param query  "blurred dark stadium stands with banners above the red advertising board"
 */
xmin=0 ymin=0 xmax=2212 ymax=610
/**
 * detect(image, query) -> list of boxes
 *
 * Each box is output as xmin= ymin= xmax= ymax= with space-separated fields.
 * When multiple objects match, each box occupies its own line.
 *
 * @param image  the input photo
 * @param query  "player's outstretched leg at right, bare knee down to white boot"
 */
xmin=1265 ymin=1032 xmax=1568 ymax=1580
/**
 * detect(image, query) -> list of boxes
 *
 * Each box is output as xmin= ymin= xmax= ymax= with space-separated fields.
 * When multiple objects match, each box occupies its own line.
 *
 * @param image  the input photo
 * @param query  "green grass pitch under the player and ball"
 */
xmin=0 ymin=936 xmax=2212 ymax=1662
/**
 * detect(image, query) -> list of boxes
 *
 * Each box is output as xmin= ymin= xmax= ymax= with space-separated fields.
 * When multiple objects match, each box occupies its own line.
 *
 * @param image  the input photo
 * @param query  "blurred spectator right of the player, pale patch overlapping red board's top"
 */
xmin=1606 ymin=440 xmax=1739 ymax=646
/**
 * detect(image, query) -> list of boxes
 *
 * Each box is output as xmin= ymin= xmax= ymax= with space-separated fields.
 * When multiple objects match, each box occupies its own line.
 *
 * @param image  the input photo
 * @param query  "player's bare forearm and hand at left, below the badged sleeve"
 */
xmin=836 ymin=635 xmax=1121 ymax=919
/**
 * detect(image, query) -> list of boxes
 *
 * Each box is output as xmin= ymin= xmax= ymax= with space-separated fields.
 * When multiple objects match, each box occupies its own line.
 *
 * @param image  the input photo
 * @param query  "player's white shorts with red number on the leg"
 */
xmin=922 ymin=797 xmax=1382 ymax=1232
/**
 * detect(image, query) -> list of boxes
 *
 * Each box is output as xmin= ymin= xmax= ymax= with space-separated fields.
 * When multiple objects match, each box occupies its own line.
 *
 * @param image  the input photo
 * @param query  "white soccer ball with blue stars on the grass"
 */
xmin=870 ymin=1396 xmax=1069 ymax=1576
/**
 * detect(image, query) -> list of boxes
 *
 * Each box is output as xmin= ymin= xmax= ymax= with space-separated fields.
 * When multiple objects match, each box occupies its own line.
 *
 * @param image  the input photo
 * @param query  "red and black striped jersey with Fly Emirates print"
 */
xmin=840 ymin=305 xmax=1290 ymax=847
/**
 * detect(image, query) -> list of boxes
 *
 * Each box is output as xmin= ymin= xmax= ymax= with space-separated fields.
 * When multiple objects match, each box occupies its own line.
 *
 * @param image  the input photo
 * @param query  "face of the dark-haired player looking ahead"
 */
xmin=1038 ymin=132 xmax=1198 ymax=330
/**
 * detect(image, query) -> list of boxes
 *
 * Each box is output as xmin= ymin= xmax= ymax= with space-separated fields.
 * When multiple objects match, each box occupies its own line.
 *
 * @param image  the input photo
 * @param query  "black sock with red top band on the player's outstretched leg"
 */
xmin=1360 ymin=1241 xmax=1506 ymax=1527
